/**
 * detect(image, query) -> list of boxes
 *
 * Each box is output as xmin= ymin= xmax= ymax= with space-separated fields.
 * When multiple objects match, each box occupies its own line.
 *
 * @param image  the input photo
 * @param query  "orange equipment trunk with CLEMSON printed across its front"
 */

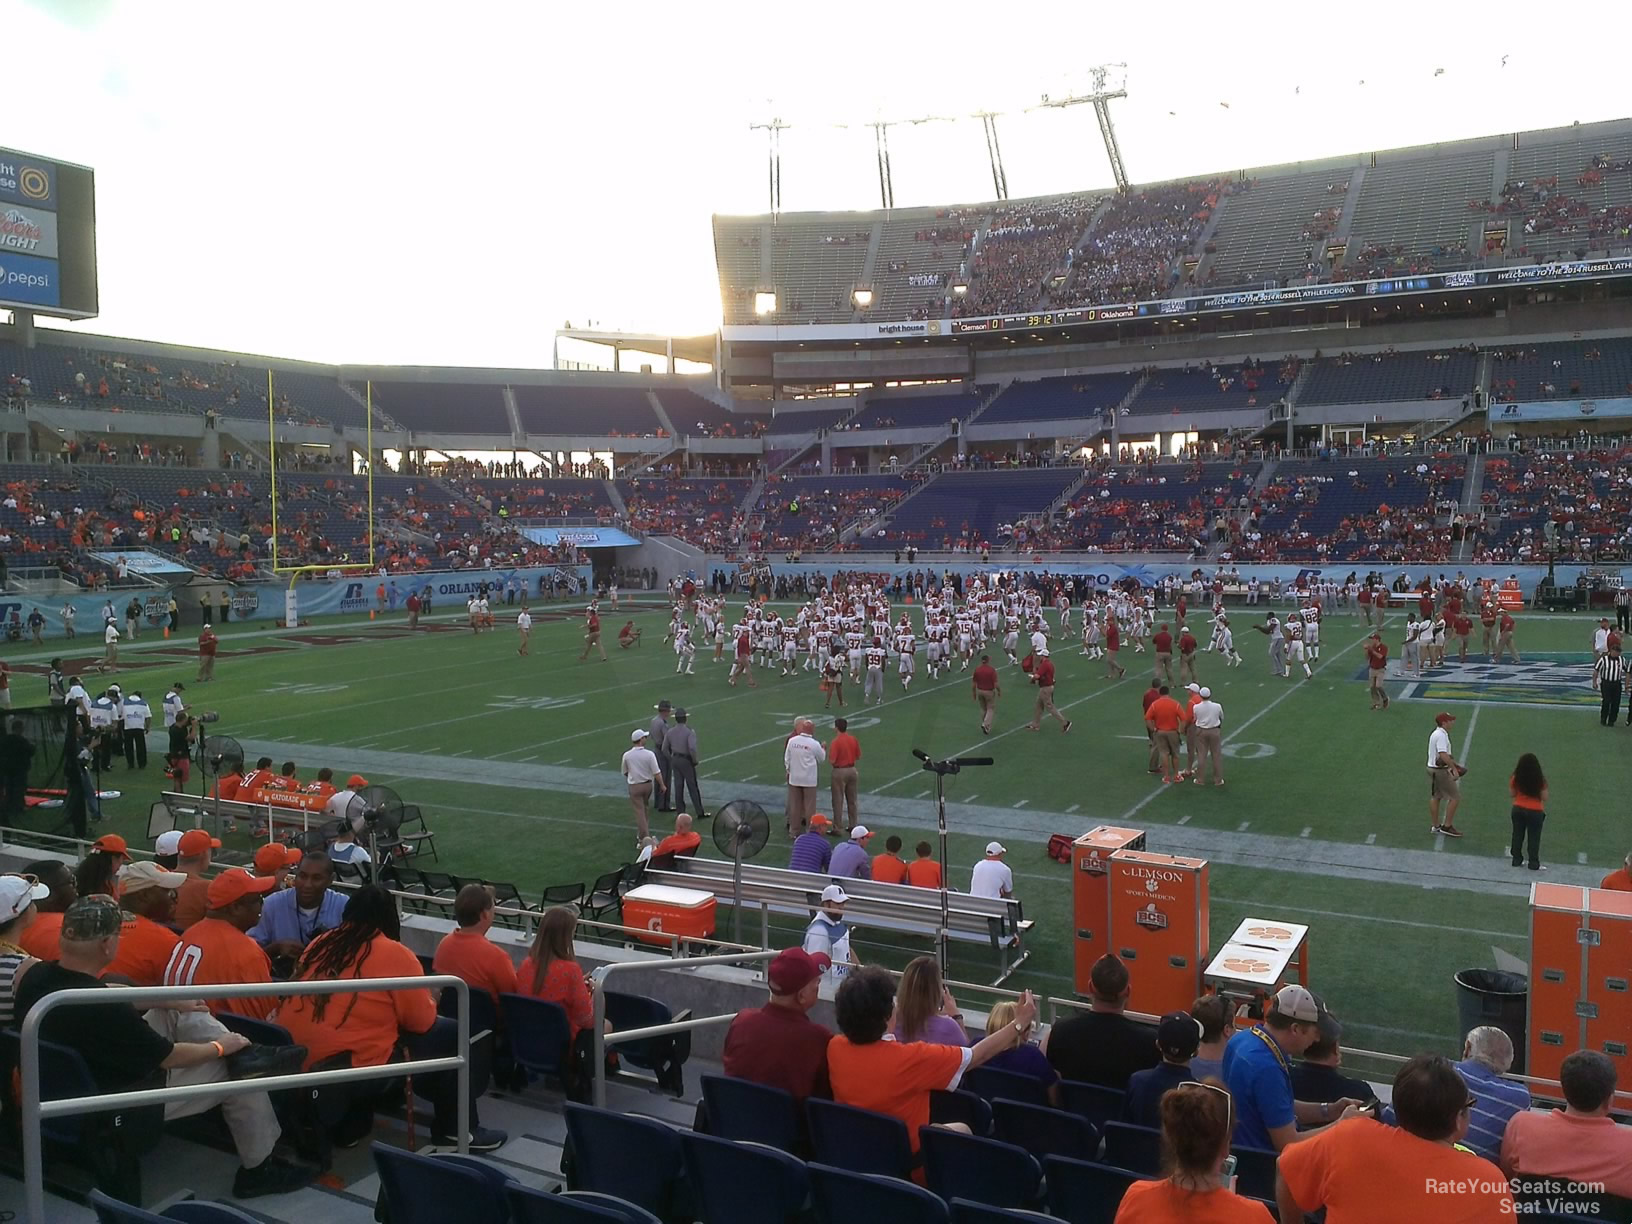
xmin=1110 ymin=850 xmax=1209 ymax=1015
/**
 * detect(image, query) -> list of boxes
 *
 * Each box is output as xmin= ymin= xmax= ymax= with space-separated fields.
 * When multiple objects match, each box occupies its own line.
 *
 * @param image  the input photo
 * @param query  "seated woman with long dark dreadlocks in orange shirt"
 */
xmin=276 ymin=885 xmax=509 ymax=1152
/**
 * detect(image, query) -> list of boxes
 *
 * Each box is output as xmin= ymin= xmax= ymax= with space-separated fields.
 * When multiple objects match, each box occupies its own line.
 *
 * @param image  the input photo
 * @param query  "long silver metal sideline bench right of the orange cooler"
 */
xmin=646 ymin=857 xmax=1031 ymax=986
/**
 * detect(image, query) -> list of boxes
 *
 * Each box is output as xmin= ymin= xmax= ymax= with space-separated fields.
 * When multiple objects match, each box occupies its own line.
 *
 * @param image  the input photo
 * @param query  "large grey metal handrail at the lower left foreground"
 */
xmin=20 ymin=974 xmax=470 ymax=1224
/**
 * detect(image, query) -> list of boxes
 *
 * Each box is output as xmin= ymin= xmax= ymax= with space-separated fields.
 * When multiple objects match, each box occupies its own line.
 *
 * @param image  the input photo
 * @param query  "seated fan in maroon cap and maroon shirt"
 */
xmin=723 ymin=948 xmax=832 ymax=1102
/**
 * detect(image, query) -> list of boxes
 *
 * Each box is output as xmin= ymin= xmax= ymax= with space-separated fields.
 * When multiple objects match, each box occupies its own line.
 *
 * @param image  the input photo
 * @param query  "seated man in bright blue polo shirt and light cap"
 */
xmin=1224 ymin=986 xmax=1361 ymax=1152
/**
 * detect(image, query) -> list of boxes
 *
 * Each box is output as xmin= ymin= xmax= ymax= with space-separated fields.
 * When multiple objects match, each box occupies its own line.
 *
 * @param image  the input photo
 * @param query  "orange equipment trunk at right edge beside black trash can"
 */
xmin=1526 ymin=885 xmax=1632 ymax=1108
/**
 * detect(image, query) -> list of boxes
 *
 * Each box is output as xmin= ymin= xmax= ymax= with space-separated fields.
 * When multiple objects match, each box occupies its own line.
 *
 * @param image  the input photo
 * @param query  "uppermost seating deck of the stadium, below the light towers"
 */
xmin=713 ymin=121 xmax=1632 ymax=326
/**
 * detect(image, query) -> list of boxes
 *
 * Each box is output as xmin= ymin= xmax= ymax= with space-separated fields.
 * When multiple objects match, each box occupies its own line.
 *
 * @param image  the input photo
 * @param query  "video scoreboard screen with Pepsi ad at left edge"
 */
xmin=0 ymin=149 xmax=96 ymax=318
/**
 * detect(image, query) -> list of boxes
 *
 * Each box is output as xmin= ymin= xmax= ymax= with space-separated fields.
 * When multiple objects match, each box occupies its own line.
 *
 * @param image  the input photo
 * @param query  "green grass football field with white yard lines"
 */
xmin=11 ymin=609 xmax=1632 ymax=1077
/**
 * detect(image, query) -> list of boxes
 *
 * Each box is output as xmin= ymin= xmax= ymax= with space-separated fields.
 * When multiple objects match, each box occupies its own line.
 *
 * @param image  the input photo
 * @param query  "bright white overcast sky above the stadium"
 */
xmin=0 ymin=0 xmax=1632 ymax=367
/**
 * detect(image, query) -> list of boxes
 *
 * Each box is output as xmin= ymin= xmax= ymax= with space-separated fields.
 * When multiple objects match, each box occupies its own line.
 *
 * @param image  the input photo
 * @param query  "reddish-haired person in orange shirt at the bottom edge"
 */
xmin=1116 ymin=1080 xmax=1275 ymax=1224
